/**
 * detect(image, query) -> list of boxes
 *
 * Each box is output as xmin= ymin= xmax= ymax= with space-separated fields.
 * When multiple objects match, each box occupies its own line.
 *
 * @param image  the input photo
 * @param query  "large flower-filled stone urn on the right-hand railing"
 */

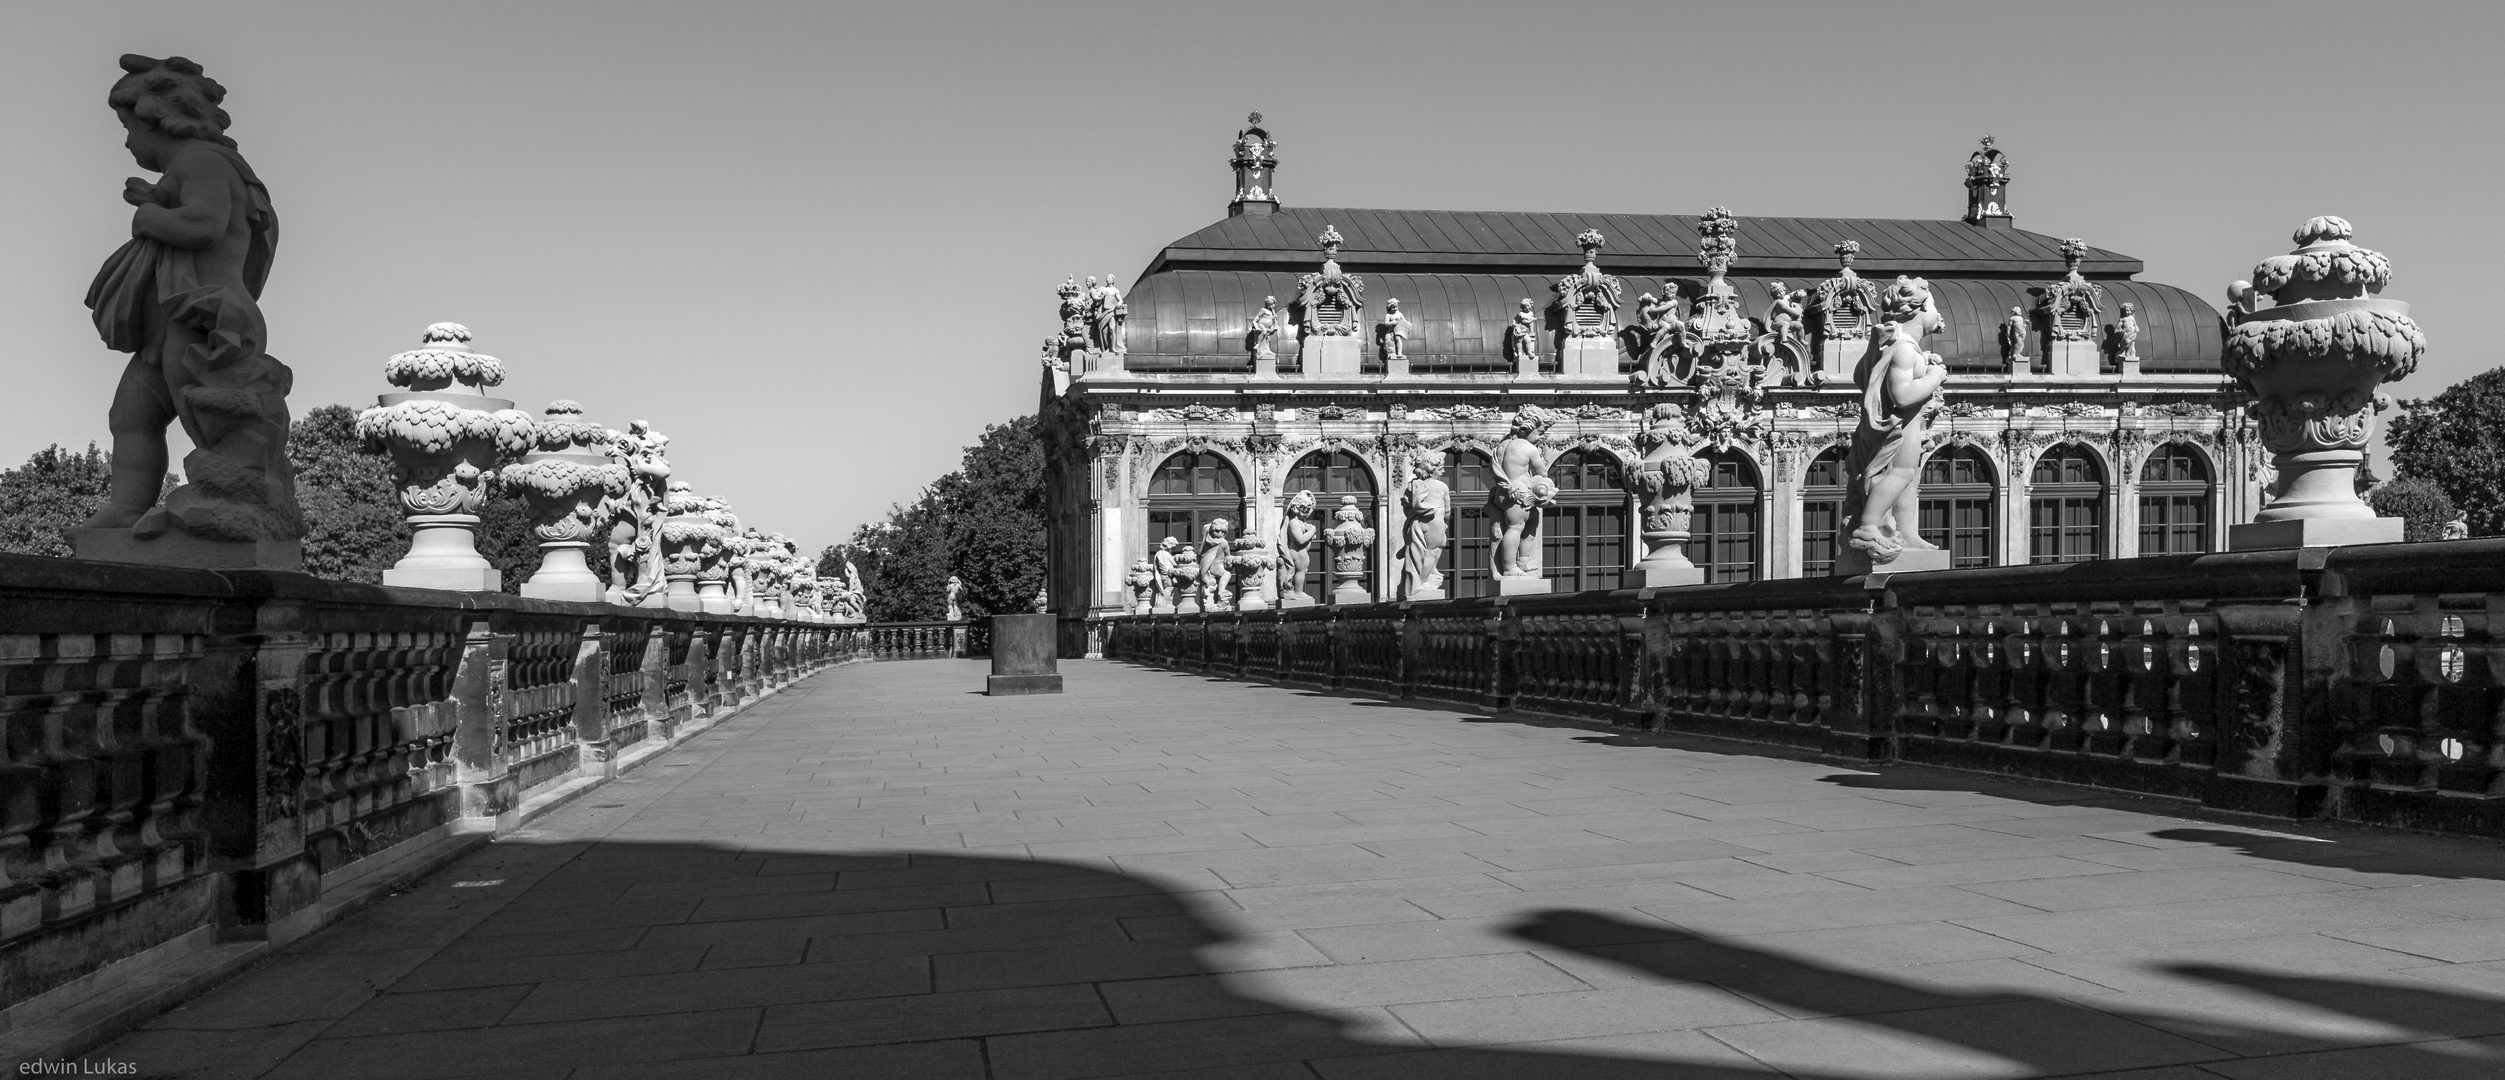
xmin=2222 ymin=218 xmax=2427 ymax=551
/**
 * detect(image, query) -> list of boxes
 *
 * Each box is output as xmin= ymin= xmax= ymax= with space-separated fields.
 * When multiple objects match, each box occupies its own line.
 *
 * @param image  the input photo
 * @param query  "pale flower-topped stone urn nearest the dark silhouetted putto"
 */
xmin=356 ymin=323 xmax=534 ymax=591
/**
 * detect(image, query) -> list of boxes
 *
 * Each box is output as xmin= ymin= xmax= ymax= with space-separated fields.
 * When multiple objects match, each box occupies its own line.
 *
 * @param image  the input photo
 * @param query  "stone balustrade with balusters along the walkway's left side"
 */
xmin=0 ymin=556 xmax=867 ymax=1012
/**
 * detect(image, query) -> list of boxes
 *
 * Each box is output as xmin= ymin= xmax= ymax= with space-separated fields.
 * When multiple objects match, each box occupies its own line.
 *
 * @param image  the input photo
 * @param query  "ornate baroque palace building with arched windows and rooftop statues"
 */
xmin=1042 ymin=113 xmax=2270 ymax=616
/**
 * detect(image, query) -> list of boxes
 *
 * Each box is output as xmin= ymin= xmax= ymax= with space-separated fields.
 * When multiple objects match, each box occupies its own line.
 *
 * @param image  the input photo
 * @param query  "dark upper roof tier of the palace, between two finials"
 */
xmin=1150 ymin=208 xmax=2142 ymax=278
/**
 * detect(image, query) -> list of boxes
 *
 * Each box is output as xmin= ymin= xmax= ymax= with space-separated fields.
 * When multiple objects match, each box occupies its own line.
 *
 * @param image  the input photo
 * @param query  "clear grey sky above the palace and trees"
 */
xmin=0 ymin=0 xmax=2505 ymax=549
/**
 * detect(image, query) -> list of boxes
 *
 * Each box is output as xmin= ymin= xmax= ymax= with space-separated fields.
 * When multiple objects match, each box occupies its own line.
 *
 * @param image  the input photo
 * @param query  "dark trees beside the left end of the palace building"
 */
xmin=817 ymin=416 xmax=1045 ymax=621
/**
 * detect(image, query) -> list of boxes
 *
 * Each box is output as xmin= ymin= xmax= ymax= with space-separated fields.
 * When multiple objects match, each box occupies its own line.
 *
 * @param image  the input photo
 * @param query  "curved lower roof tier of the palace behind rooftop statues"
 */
xmin=1122 ymin=268 xmax=2219 ymax=373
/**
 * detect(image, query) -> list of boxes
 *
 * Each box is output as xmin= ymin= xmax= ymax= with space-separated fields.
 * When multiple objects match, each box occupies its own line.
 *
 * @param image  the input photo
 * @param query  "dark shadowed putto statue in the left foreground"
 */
xmin=70 ymin=53 xmax=306 ymax=569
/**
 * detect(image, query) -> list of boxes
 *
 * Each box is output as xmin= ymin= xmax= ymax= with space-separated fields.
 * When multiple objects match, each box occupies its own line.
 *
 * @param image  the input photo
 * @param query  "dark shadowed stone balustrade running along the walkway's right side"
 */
xmin=1105 ymin=539 xmax=2505 ymax=837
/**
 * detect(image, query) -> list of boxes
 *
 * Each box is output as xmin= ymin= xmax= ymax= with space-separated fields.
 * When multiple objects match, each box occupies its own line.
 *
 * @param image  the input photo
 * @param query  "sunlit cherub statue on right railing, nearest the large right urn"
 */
xmin=1836 ymin=278 xmax=1949 ymax=576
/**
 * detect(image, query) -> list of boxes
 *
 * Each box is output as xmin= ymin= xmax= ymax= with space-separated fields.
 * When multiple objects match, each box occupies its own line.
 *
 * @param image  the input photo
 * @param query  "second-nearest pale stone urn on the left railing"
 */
xmin=498 ymin=401 xmax=626 ymax=604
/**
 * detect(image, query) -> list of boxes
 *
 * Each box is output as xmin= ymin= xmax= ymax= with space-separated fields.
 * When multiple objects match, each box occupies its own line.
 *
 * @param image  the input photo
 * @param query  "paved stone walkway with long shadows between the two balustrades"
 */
xmin=95 ymin=662 xmax=2505 ymax=1080
